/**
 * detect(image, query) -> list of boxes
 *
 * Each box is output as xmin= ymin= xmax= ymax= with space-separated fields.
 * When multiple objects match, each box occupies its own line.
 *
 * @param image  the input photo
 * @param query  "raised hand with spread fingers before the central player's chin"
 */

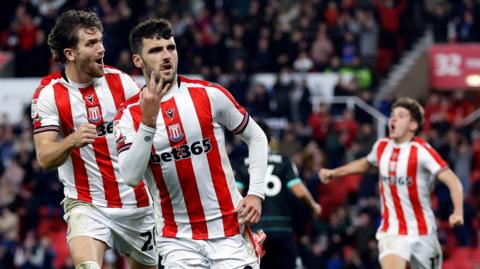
xmin=140 ymin=71 xmax=171 ymax=128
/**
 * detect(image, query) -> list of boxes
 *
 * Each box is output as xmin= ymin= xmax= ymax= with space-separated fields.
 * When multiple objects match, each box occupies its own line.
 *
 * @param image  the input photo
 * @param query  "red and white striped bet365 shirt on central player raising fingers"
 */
xmin=115 ymin=76 xmax=249 ymax=240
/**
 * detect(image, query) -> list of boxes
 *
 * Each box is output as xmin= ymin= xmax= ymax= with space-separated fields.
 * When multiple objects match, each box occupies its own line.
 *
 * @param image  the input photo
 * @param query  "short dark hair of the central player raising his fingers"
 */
xmin=128 ymin=19 xmax=175 ymax=54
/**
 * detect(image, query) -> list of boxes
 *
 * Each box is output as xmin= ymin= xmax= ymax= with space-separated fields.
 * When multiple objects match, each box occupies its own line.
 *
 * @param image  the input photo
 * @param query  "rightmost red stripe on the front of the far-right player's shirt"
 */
xmin=407 ymin=146 xmax=427 ymax=235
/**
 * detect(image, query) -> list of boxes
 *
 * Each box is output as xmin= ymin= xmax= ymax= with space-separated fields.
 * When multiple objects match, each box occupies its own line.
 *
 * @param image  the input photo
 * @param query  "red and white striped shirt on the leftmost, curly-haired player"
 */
xmin=32 ymin=67 xmax=150 ymax=208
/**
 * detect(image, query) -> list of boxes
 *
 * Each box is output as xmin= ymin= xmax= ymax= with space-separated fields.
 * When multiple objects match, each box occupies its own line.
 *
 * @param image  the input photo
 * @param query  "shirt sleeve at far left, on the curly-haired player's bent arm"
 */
xmin=31 ymin=89 xmax=60 ymax=134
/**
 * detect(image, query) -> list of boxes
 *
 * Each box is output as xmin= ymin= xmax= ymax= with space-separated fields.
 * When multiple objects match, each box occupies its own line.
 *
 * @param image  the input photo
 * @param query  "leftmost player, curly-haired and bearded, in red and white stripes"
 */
xmin=32 ymin=10 xmax=158 ymax=269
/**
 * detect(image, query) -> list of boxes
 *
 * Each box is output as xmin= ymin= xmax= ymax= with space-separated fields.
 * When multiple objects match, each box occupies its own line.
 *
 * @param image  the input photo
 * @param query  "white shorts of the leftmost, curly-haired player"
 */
xmin=62 ymin=198 xmax=158 ymax=266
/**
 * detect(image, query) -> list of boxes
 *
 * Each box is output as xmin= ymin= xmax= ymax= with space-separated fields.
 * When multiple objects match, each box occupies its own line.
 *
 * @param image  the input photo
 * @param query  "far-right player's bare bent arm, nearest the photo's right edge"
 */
xmin=438 ymin=168 xmax=463 ymax=227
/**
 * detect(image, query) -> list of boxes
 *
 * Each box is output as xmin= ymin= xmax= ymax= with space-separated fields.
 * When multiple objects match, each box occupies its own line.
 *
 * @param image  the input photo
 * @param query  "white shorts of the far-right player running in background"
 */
xmin=377 ymin=231 xmax=443 ymax=269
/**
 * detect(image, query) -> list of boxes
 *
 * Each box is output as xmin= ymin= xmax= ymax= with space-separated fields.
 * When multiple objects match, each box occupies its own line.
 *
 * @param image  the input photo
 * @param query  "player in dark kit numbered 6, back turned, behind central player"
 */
xmin=235 ymin=121 xmax=321 ymax=269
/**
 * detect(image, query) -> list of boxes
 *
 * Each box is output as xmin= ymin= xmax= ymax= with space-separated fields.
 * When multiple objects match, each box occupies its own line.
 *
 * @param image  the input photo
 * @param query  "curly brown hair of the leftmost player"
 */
xmin=47 ymin=10 xmax=103 ymax=63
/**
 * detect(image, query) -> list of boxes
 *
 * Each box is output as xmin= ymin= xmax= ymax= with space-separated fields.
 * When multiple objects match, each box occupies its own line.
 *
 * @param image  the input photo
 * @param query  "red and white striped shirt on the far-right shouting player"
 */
xmin=367 ymin=137 xmax=447 ymax=235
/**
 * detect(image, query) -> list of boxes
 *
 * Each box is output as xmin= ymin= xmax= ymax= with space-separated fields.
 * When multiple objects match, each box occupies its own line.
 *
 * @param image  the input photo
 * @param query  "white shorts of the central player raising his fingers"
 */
xmin=157 ymin=231 xmax=260 ymax=269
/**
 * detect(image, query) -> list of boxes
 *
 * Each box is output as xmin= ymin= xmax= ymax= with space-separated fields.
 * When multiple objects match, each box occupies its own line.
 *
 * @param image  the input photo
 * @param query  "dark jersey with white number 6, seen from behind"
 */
xmin=235 ymin=154 xmax=301 ymax=234
